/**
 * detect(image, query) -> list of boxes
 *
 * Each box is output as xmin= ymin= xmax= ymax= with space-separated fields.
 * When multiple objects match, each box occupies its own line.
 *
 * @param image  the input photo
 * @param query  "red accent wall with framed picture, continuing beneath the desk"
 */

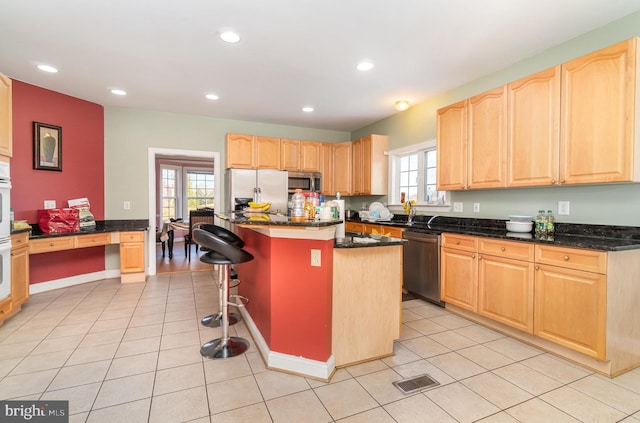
xmin=11 ymin=80 xmax=105 ymax=284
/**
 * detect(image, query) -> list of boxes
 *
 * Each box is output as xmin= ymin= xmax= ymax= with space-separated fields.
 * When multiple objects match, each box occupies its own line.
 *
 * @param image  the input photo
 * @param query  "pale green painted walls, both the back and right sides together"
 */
xmin=105 ymin=12 xmax=640 ymax=226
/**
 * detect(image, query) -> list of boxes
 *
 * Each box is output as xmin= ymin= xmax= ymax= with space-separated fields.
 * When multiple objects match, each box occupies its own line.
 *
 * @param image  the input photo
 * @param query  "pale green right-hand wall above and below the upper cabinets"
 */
xmin=352 ymin=12 xmax=640 ymax=226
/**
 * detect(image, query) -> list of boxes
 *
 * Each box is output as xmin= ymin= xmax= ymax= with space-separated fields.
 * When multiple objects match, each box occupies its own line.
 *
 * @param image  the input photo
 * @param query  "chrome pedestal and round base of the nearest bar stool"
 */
xmin=200 ymin=265 xmax=249 ymax=359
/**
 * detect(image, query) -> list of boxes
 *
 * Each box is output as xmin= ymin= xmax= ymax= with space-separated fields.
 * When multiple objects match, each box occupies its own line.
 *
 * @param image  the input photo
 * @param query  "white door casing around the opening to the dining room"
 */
xmin=147 ymin=147 xmax=224 ymax=275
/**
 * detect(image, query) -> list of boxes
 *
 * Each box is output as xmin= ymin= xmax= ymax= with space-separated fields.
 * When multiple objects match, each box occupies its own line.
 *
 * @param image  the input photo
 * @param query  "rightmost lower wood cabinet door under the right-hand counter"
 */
xmin=534 ymin=265 xmax=607 ymax=360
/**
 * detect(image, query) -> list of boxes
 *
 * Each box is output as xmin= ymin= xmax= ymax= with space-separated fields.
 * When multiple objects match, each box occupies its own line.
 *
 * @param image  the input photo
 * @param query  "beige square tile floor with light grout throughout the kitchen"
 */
xmin=0 ymin=271 xmax=640 ymax=423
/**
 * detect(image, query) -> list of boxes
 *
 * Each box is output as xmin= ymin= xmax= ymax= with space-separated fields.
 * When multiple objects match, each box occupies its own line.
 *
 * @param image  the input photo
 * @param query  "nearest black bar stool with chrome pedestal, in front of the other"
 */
xmin=193 ymin=228 xmax=253 ymax=358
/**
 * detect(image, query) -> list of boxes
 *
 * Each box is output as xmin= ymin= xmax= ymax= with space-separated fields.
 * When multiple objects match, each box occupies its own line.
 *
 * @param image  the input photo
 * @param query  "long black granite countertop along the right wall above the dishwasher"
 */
xmin=349 ymin=215 xmax=640 ymax=251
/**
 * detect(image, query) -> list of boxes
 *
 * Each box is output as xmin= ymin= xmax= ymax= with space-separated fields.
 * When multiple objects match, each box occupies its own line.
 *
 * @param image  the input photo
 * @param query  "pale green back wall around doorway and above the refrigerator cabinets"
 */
xmin=104 ymin=107 xmax=350 ymax=219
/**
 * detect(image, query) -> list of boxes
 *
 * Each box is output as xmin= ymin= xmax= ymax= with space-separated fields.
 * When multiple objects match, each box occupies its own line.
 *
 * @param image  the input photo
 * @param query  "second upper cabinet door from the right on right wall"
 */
xmin=507 ymin=66 xmax=560 ymax=187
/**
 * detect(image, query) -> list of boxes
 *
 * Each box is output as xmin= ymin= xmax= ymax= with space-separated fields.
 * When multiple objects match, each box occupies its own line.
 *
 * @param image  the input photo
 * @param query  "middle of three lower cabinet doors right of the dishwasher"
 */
xmin=478 ymin=254 xmax=534 ymax=333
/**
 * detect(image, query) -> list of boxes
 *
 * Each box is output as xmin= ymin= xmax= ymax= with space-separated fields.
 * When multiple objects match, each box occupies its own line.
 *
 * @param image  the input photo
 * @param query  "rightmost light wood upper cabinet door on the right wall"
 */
xmin=560 ymin=38 xmax=640 ymax=184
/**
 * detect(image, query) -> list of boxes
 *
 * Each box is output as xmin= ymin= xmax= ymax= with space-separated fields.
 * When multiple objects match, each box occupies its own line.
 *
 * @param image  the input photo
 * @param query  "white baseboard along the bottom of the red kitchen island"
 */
xmin=238 ymin=306 xmax=336 ymax=382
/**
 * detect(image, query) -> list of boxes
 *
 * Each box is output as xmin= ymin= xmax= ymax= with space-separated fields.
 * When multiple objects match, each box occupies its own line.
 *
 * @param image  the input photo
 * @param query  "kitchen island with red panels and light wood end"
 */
xmin=231 ymin=216 xmax=402 ymax=381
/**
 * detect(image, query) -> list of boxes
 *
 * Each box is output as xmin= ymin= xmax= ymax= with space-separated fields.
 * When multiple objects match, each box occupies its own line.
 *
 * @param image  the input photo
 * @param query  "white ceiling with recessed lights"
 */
xmin=0 ymin=0 xmax=640 ymax=131
